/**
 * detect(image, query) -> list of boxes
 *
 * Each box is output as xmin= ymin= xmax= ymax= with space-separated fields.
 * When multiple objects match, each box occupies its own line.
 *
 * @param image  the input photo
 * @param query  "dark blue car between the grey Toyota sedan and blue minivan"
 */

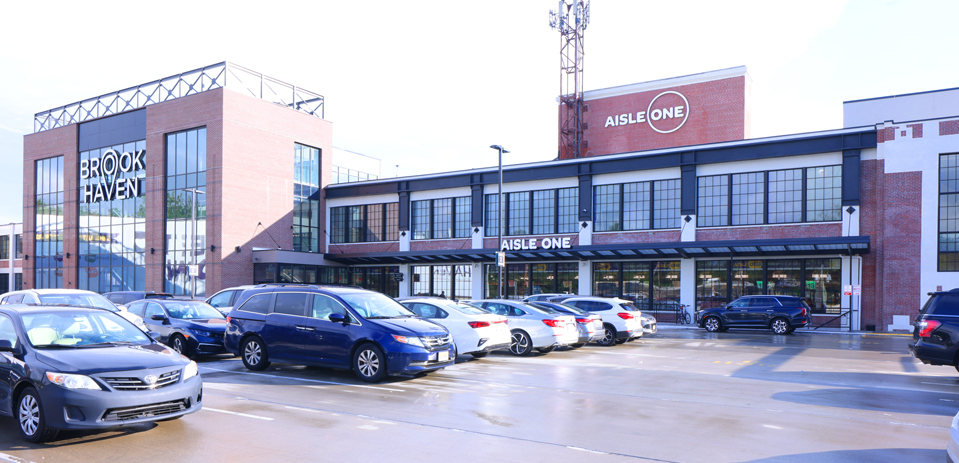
xmin=128 ymin=299 xmax=226 ymax=357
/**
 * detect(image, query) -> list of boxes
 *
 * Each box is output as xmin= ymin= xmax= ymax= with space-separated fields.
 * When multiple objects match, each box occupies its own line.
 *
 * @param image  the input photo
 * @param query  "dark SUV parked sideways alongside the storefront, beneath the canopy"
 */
xmin=696 ymin=296 xmax=810 ymax=334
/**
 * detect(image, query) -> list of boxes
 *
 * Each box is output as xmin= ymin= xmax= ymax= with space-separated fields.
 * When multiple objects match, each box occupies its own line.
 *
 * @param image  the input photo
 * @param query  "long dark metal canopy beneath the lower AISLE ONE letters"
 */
xmin=324 ymin=236 xmax=870 ymax=265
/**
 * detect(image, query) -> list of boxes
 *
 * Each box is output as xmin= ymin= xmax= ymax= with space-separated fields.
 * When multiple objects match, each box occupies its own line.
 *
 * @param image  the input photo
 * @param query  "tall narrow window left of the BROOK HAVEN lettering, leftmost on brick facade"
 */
xmin=33 ymin=156 xmax=63 ymax=288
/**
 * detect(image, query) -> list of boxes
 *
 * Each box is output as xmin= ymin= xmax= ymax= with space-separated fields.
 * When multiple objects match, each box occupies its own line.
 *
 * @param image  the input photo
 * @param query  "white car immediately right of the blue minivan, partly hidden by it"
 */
xmin=401 ymin=298 xmax=511 ymax=358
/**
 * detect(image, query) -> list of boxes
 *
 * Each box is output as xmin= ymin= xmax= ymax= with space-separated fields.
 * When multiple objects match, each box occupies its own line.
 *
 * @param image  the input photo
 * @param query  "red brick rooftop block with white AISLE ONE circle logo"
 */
xmin=568 ymin=66 xmax=750 ymax=160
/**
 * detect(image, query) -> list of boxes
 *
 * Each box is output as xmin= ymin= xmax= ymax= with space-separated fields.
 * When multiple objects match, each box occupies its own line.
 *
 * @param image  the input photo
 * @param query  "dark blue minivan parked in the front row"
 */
xmin=224 ymin=285 xmax=456 ymax=382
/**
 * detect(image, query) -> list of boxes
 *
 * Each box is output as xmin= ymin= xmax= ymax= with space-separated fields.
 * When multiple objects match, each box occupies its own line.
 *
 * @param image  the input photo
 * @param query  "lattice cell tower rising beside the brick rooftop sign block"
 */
xmin=549 ymin=0 xmax=589 ymax=159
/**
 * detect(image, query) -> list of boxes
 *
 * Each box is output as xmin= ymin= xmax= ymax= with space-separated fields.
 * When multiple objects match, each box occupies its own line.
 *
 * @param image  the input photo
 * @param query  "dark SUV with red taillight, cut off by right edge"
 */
xmin=909 ymin=288 xmax=959 ymax=370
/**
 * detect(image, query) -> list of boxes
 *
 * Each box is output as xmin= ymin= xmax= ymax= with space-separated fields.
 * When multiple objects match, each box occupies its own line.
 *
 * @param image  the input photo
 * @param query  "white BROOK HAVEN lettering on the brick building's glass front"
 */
xmin=80 ymin=149 xmax=146 ymax=203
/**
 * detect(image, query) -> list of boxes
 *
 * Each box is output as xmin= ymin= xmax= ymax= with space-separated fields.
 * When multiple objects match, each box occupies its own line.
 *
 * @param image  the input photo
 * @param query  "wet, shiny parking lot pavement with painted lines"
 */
xmin=0 ymin=326 xmax=959 ymax=462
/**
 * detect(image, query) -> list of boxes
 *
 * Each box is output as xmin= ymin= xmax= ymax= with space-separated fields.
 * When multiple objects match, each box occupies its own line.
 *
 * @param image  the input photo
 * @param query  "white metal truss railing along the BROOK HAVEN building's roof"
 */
xmin=33 ymin=61 xmax=325 ymax=133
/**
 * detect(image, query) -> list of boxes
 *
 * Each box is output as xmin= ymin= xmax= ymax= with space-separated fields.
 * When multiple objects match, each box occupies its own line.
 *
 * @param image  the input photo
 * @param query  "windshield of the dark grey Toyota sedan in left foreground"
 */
xmin=22 ymin=310 xmax=152 ymax=349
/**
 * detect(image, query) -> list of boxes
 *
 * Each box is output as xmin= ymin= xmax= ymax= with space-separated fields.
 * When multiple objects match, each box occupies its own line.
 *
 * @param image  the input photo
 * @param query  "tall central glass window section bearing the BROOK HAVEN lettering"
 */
xmin=77 ymin=139 xmax=148 ymax=293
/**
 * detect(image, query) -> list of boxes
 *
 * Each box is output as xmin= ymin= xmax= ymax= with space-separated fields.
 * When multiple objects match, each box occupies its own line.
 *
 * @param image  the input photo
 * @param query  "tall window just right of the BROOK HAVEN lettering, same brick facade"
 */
xmin=164 ymin=128 xmax=205 ymax=296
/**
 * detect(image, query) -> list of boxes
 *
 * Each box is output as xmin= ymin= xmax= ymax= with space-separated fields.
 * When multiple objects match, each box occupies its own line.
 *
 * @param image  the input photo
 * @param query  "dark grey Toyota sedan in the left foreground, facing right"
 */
xmin=0 ymin=304 xmax=203 ymax=442
